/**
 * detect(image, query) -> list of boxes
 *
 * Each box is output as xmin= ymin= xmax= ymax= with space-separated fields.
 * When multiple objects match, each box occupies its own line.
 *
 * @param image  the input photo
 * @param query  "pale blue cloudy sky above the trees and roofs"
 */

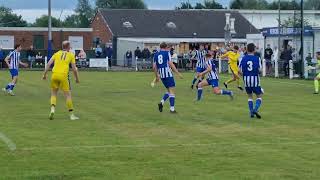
xmin=0 ymin=0 xmax=231 ymax=23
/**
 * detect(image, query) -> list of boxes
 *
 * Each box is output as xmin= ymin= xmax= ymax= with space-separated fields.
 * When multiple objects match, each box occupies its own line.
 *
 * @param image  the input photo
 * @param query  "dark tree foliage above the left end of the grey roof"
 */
xmin=96 ymin=0 xmax=147 ymax=9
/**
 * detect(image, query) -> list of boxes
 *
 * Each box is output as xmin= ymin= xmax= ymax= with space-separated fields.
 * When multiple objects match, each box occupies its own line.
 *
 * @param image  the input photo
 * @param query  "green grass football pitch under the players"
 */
xmin=0 ymin=71 xmax=320 ymax=180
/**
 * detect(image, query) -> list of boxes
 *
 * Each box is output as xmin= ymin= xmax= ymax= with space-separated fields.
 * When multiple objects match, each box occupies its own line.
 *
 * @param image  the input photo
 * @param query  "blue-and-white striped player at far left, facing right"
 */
xmin=2 ymin=44 xmax=28 ymax=96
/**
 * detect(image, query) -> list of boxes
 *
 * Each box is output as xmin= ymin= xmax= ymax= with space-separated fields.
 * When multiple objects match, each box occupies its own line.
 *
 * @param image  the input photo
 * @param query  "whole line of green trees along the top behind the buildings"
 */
xmin=0 ymin=0 xmax=320 ymax=28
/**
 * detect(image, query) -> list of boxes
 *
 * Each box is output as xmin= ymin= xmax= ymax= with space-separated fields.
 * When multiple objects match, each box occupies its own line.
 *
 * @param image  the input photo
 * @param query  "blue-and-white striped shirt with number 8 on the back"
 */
xmin=154 ymin=50 xmax=173 ymax=79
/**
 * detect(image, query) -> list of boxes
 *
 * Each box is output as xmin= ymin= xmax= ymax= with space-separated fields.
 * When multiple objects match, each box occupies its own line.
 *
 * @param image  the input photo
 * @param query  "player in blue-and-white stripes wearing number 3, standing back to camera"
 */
xmin=239 ymin=43 xmax=263 ymax=119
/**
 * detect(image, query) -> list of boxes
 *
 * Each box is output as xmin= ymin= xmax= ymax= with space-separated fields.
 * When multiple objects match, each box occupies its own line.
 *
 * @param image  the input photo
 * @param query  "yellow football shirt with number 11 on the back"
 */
xmin=52 ymin=51 xmax=76 ymax=75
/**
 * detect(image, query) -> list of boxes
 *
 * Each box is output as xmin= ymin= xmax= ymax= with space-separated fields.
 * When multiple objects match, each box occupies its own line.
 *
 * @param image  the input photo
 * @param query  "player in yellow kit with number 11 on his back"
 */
xmin=42 ymin=41 xmax=79 ymax=120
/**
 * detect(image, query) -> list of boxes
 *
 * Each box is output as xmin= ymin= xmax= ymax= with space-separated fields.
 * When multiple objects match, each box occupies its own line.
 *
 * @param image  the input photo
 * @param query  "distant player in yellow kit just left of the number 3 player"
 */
xmin=220 ymin=46 xmax=243 ymax=91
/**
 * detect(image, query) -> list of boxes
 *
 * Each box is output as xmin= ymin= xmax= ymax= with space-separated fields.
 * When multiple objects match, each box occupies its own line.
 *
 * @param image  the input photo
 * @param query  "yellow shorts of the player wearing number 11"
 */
xmin=51 ymin=73 xmax=70 ymax=92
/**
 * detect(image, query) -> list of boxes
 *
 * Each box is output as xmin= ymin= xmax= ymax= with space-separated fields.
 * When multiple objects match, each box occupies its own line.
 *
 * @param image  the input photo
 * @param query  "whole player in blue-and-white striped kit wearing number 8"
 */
xmin=153 ymin=43 xmax=182 ymax=113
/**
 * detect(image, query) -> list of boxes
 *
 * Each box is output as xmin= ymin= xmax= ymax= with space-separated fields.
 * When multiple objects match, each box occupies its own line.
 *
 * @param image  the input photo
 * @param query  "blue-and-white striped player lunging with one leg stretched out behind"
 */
xmin=197 ymin=53 xmax=233 ymax=101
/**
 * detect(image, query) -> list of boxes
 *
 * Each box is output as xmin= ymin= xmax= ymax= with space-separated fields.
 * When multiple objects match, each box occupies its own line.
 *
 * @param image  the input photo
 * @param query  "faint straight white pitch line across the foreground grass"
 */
xmin=20 ymin=141 xmax=320 ymax=151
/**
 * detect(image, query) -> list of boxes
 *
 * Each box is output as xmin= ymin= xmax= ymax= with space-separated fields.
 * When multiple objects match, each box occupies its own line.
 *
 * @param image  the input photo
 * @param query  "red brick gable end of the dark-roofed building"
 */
xmin=91 ymin=11 xmax=112 ymax=44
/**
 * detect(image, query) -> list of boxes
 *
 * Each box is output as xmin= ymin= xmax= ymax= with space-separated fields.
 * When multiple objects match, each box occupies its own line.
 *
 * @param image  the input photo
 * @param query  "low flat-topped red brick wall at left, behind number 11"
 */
xmin=0 ymin=31 xmax=93 ymax=50
